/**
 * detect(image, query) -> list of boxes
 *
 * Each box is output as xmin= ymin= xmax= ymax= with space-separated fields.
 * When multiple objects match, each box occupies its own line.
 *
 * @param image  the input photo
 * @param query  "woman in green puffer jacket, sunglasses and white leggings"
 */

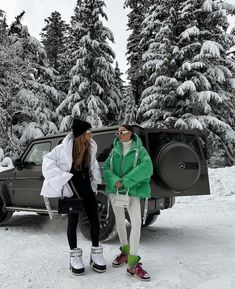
xmin=103 ymin=125 xmax=153 ymax=281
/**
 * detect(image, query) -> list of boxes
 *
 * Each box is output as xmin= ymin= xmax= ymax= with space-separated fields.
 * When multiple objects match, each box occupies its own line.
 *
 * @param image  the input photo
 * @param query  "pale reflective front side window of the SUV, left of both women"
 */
xmin=24 ymin=142 xmax=51 ymax=166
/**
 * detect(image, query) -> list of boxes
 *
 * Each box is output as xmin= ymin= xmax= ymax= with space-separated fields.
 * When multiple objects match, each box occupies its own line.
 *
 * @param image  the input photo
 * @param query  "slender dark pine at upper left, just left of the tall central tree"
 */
xmin=41 ymin=11 xmax=71 ymax=94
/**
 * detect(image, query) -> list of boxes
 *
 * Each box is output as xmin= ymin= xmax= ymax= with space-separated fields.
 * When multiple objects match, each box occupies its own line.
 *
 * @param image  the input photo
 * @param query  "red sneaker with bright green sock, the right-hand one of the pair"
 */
xmin=127 ymin=255 xmax=150 ymax=281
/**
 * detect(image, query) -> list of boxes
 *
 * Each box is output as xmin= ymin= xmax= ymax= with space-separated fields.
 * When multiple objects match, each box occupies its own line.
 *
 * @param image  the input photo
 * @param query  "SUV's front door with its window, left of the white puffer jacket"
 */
xmin=12 ymin=140 xmax=52 ymax=207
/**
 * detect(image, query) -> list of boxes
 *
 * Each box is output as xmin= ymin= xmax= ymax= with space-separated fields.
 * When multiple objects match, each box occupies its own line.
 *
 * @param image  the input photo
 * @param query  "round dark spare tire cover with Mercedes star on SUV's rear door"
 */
xmin=155 ymin=142 xmax=201 ymax=190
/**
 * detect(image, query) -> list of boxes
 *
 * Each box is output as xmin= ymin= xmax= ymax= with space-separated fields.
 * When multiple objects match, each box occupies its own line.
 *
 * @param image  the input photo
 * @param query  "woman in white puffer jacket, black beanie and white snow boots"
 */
xmin=41 ymin=118 xmax=106 ymax=275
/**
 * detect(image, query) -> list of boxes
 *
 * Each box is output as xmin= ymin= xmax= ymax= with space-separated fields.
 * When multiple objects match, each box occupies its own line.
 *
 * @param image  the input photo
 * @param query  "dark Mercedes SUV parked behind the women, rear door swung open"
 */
xmin=0 ymin=126 xmax=210 ymax=240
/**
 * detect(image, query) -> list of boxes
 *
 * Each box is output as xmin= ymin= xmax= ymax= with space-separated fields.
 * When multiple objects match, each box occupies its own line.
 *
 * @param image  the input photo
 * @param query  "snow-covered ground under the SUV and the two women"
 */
xmin=0 ymin=167 xmax=235 ymax=289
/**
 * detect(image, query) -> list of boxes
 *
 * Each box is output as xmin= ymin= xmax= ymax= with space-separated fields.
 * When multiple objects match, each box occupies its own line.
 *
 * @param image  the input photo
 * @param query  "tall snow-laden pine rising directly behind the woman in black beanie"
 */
xmin=58 ymin=0 xmax=119 ymax=131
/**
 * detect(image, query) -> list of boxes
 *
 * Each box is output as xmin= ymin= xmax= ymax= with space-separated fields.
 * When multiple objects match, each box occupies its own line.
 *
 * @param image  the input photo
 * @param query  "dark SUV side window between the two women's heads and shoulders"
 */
xmin=93 ymin=131 xmax=115 ymax=162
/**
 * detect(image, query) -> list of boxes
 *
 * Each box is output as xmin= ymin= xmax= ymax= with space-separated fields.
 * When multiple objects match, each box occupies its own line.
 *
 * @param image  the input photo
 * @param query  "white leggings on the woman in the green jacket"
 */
xmin=111 ymin=197 xmax=141 ymax=256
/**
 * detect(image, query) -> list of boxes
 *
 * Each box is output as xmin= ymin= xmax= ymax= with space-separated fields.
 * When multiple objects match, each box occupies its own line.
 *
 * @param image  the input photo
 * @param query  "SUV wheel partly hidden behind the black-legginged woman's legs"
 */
xmin=78 ymin=192 xmax=117 ymax=241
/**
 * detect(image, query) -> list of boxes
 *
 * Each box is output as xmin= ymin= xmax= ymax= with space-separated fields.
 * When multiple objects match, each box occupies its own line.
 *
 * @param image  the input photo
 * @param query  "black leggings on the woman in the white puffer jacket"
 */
xmin=67 ymin=189 xmax=100 ymax=250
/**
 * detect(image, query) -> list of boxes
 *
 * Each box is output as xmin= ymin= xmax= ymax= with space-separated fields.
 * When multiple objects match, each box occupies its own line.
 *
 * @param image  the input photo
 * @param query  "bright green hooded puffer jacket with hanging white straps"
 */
xmin=103 ymin=134 xmax=153 ymax=198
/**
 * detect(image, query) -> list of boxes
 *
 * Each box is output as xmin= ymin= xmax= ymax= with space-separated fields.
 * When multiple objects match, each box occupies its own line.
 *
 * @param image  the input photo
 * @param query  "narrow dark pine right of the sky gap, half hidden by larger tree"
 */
xmin=124 ymin=0 xmax=154 ymax=104
